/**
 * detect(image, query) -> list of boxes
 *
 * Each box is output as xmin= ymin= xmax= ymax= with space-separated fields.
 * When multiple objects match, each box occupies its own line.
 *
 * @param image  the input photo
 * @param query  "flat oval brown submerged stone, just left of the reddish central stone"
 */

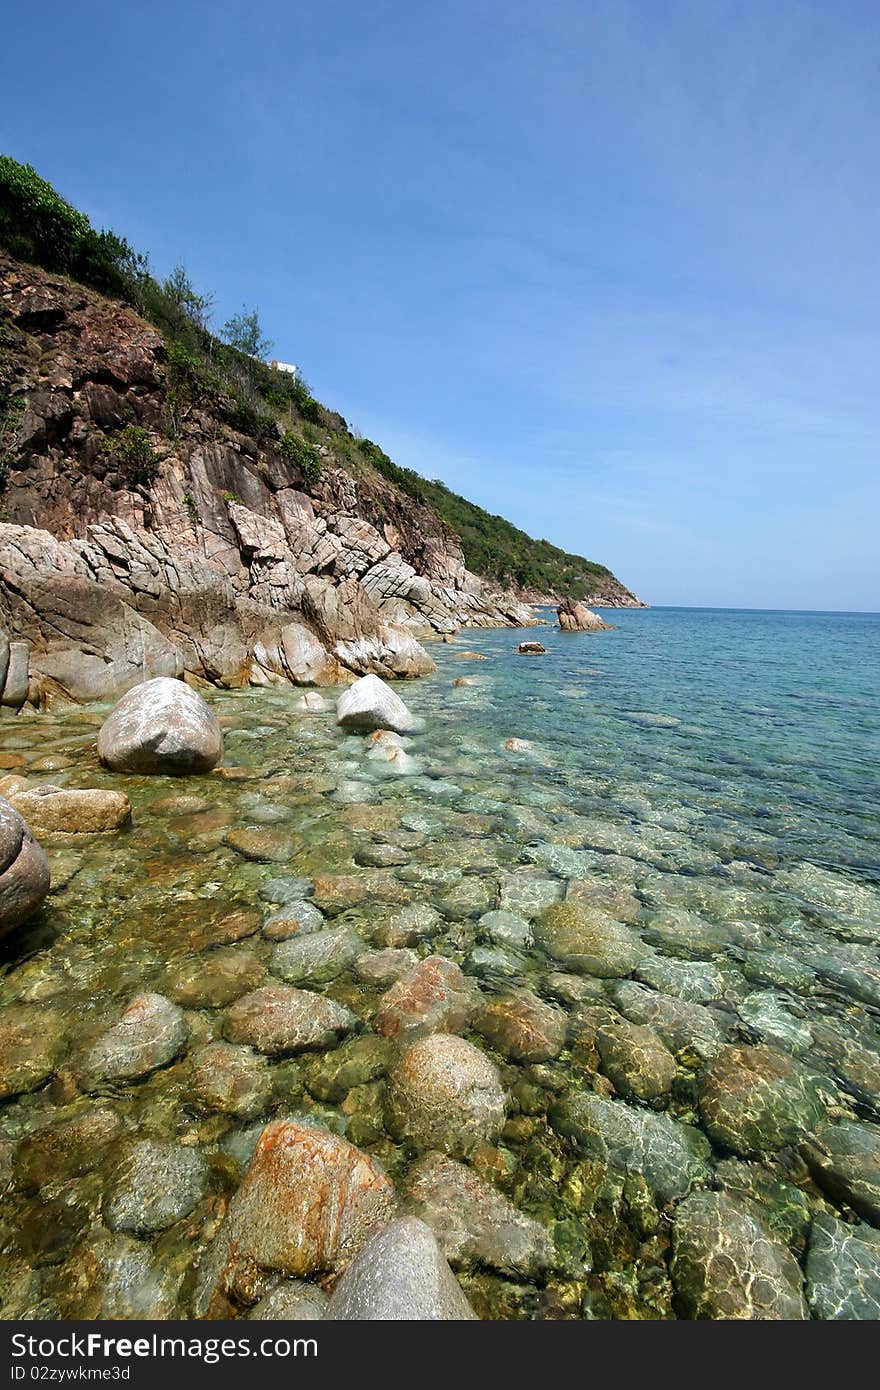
xmin=224 ymin=984 xmax=357 ymax=1056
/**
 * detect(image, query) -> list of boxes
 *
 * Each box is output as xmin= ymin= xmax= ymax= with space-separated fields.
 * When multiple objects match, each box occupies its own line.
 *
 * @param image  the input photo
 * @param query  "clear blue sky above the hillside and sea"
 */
xmin=0 ymin=0 xmax=880 ymax=610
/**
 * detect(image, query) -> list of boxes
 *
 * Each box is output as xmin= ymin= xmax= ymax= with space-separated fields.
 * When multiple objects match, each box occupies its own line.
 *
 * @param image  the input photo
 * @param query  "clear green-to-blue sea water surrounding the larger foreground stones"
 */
xmin=0 ymin=609 xmax=880 ymax=1318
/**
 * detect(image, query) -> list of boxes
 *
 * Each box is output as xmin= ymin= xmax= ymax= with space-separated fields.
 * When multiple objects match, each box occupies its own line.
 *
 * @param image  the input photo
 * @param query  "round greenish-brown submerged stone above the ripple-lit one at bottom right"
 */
xmin=699 ymin=1045 xmax=826 ymax=1158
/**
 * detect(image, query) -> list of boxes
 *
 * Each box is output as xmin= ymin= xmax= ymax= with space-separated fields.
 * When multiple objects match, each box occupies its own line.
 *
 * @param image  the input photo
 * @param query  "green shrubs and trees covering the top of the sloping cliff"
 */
xmin=0 ymin=154 xmax=631 ymax=598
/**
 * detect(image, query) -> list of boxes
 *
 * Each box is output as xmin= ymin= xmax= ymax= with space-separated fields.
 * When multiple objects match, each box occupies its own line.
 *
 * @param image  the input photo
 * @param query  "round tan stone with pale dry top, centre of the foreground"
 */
xmin=386 ymin=1033 xmax=507 ymax=1156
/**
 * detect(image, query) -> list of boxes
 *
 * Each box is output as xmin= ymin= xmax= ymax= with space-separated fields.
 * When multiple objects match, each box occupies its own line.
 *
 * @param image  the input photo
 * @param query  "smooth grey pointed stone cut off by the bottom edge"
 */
xmin=325 ymin=1216 xmax=477 ymax=1322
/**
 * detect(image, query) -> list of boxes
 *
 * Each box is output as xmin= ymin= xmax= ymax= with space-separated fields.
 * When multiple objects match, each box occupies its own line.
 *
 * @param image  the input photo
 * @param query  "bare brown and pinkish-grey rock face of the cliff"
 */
xmin=0 ymin=256 xmax=534 ymax=706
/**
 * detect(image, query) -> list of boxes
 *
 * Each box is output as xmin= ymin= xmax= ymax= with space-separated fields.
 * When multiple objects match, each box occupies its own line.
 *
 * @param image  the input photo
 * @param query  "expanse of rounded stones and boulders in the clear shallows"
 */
xmin=0 ymin=661 xmax=880 ymax=1321
